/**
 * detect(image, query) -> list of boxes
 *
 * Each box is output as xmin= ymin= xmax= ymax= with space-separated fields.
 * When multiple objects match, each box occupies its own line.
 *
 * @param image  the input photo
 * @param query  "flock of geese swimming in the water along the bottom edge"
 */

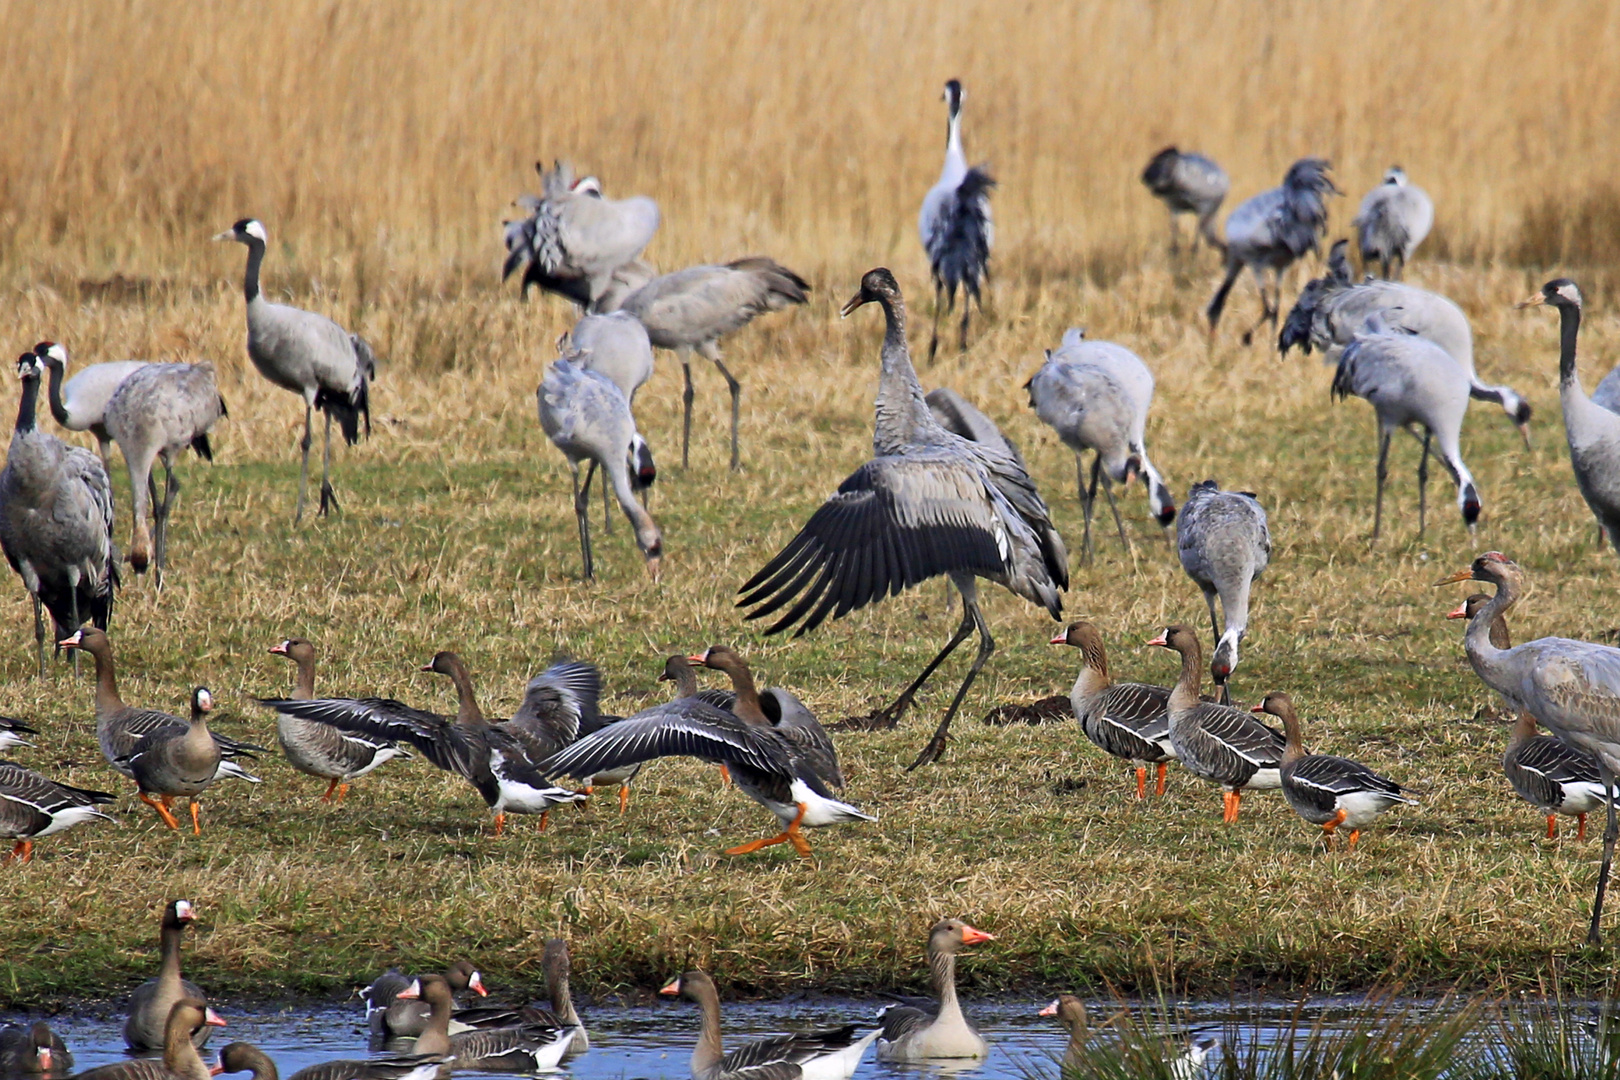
xmin=0 ymin=900 xmax=1217 ymax=1080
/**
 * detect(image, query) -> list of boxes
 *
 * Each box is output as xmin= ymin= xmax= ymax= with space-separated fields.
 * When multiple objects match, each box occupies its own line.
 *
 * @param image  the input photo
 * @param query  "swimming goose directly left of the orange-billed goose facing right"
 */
xmin=658 ymin=970 xmax=878 ymax=1080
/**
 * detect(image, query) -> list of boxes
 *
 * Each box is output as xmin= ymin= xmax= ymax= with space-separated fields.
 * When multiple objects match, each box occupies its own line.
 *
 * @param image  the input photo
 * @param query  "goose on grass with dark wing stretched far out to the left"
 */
xmin=259 ymin=653 xmax=585 ymax=836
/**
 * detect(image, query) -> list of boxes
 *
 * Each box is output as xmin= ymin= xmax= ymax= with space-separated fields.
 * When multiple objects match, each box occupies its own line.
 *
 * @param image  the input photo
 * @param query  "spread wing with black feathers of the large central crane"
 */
xmin=737 ymin=453 xmax=1013 ymax=636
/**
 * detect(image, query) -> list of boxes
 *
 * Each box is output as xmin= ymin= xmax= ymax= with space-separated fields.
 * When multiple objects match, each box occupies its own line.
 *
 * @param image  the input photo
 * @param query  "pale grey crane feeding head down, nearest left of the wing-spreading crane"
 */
xmin=536 ymin=356 xmax=664 ymax=580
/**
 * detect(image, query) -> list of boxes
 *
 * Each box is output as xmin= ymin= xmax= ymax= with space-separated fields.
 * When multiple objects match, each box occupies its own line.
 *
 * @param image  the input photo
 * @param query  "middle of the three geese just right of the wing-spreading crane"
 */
xmin=1149 ymin=623 xmax=1283 ymax=824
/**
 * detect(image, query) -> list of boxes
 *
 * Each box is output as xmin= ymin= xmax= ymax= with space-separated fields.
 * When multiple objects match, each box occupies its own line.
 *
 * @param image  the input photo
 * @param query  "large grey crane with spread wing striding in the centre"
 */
xmin=737 ymin=275 xmax=1069 ymax=769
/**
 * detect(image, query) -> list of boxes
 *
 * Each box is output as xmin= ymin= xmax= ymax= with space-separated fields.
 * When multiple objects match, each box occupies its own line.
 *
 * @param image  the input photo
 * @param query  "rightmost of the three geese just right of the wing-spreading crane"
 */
xmin=1252 ymin=691 xmax=1418 ymax=850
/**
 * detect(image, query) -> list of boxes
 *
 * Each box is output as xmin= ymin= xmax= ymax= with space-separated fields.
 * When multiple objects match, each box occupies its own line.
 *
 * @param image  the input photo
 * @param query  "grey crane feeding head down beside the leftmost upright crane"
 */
xmin=107 ymin=364 xmax=228 ymax=588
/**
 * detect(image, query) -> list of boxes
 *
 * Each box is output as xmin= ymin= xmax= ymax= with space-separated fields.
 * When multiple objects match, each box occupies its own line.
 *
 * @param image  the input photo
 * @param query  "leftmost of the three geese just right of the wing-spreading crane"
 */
xmin=1051 ymin=622 xmax=1176 ymax=798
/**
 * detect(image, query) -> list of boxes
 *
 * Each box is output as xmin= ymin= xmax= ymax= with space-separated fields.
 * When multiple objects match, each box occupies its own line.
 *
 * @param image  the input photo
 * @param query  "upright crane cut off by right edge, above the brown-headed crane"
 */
xmin=1520 ymin=277 xmax=1620 ymax=557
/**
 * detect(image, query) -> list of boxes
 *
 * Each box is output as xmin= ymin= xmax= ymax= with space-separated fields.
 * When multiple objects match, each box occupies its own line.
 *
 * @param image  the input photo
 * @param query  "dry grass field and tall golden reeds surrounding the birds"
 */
xmin=0 ymin=3 xmax=1620 ymax=1006
